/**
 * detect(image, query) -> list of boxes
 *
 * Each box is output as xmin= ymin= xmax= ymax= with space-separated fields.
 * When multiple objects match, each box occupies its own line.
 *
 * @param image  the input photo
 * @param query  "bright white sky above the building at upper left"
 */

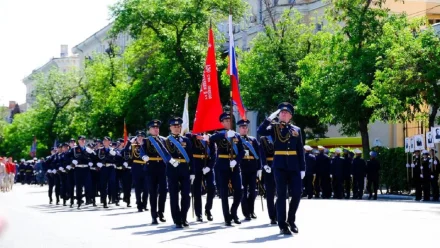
xmin=0 ymin=0 xmax=117 ymax=106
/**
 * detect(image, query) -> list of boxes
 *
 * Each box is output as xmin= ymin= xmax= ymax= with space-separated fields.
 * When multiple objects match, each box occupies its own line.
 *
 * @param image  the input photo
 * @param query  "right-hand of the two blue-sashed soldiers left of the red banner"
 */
xmin=165 ymin=117 xmax=195 ymax=228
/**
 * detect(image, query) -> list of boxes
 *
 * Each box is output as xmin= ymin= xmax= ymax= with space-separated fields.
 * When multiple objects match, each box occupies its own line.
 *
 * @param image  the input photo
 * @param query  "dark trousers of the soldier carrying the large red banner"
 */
xmin=193 ymin=170 xmax=215 ymax=217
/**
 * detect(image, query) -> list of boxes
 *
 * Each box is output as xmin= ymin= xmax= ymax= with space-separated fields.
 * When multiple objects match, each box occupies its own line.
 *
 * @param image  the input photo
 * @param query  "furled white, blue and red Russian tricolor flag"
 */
xmin=228 ymin=15 xmax=246 ymax=119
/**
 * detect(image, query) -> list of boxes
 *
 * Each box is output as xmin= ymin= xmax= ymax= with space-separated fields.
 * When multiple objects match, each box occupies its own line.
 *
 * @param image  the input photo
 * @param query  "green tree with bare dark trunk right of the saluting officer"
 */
xmin=297 ymin=0 xmax=408 ymax=157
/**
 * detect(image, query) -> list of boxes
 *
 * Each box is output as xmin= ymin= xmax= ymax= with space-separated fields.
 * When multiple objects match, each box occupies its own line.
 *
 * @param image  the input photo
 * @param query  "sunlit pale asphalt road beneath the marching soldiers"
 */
xmin=0 ymin=185 xmax=440 ymax=248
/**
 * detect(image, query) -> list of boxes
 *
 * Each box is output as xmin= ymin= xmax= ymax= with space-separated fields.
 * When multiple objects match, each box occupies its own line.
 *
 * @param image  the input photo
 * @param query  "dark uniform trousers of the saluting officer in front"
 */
xmin=273 ymin=168 xmax=302 ymax=229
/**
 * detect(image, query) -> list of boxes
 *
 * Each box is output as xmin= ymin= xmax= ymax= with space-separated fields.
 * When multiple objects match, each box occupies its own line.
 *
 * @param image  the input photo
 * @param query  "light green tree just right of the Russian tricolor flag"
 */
xmin=240 ymin=6 xmax=327 ymax=138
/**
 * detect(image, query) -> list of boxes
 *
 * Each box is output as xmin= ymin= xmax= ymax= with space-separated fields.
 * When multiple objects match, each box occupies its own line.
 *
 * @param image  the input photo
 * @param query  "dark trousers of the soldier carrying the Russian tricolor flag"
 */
xmin=216 ymin=168 xmax=242 ymax=221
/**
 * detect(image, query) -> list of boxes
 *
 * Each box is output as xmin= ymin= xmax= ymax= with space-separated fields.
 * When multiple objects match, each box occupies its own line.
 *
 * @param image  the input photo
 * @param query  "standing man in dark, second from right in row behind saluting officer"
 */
xmin=351 ymin=149 xmax=367 ymax=199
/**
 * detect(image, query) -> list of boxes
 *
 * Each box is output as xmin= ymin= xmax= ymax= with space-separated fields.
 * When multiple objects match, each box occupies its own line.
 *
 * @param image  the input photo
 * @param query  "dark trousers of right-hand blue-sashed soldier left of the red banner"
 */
xmin=168 ymin=170 xmax=191 ymax=224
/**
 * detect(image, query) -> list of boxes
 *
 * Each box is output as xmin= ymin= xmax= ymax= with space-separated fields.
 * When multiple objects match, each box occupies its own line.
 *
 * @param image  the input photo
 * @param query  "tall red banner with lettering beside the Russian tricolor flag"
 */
xmin=192 ymin=29 xmax=223 ymax=133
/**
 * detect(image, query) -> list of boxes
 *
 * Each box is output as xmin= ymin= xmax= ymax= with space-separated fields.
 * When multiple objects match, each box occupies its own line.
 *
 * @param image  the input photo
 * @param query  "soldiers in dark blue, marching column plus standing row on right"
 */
xmin=12 ymin=103 xmax=380 ymax=235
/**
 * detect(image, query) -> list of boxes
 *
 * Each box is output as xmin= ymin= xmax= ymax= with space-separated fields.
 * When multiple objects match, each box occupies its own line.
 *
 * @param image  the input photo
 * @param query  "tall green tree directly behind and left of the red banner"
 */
xmin=112 ymin=0 xmax=247 ymax=133
